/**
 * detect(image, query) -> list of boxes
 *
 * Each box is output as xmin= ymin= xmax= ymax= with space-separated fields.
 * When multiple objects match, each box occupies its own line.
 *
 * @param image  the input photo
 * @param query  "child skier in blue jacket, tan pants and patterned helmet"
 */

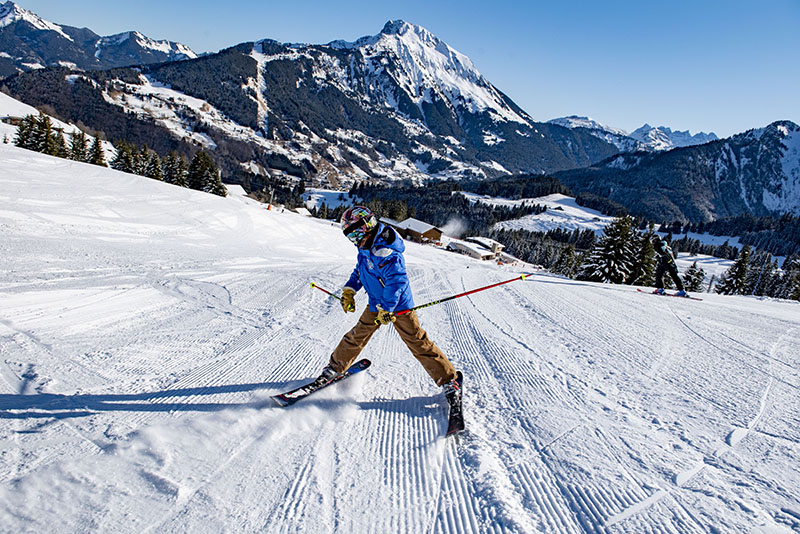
xmin=317 ymin=206 xmax=461 ymax=406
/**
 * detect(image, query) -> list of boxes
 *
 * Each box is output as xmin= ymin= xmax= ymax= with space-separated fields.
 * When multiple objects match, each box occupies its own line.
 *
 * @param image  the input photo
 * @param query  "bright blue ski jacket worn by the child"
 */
xmin=345 ymin=223 xmax=414 ymax=312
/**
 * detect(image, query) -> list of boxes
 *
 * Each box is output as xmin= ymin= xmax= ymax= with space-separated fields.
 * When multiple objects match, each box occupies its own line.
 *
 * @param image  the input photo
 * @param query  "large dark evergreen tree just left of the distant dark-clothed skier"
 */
xmin=580 ymin=215 xmax=636 ymax=284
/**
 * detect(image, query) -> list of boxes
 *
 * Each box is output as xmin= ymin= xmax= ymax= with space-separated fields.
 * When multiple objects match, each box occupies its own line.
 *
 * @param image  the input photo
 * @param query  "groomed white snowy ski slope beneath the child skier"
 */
xmin=0 ymin=144 xmax=800 ymax=534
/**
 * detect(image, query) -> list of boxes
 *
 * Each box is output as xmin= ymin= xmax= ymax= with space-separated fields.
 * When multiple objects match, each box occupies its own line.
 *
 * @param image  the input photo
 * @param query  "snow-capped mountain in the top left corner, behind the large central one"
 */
xmin=0 ymin=1 xmax=197 ymax=76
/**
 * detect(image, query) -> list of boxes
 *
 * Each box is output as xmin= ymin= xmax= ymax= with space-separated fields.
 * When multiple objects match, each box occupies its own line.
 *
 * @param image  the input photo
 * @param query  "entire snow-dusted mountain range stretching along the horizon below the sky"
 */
xmin=0 ymin=2 xmax=800 ymax=221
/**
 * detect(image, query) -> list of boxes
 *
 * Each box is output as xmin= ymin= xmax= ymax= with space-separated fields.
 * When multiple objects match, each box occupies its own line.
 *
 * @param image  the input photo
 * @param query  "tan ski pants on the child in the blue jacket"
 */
xmin=330 ymin=307 xmax=456 ymax=386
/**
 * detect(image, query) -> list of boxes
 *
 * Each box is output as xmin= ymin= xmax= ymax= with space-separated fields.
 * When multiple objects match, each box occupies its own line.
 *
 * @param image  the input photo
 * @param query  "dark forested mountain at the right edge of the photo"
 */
xmin=555 ymin=121 xmax=800 ymax=222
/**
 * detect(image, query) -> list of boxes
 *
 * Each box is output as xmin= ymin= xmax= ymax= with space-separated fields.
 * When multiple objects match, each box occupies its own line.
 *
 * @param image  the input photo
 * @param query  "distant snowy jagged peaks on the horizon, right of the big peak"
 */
xmin=548 ymin=115 xmax=719 ymax=152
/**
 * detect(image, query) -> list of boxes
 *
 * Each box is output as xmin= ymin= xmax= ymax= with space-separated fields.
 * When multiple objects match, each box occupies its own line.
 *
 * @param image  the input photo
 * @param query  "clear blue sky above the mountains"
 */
xmin=14 ymin=0 xmax=800 ymax=137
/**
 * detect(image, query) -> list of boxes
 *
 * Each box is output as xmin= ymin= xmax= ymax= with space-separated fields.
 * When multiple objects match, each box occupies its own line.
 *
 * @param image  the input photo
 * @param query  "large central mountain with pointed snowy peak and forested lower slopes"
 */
xmin=5 ymin=21 xmax=618 ymax=187
